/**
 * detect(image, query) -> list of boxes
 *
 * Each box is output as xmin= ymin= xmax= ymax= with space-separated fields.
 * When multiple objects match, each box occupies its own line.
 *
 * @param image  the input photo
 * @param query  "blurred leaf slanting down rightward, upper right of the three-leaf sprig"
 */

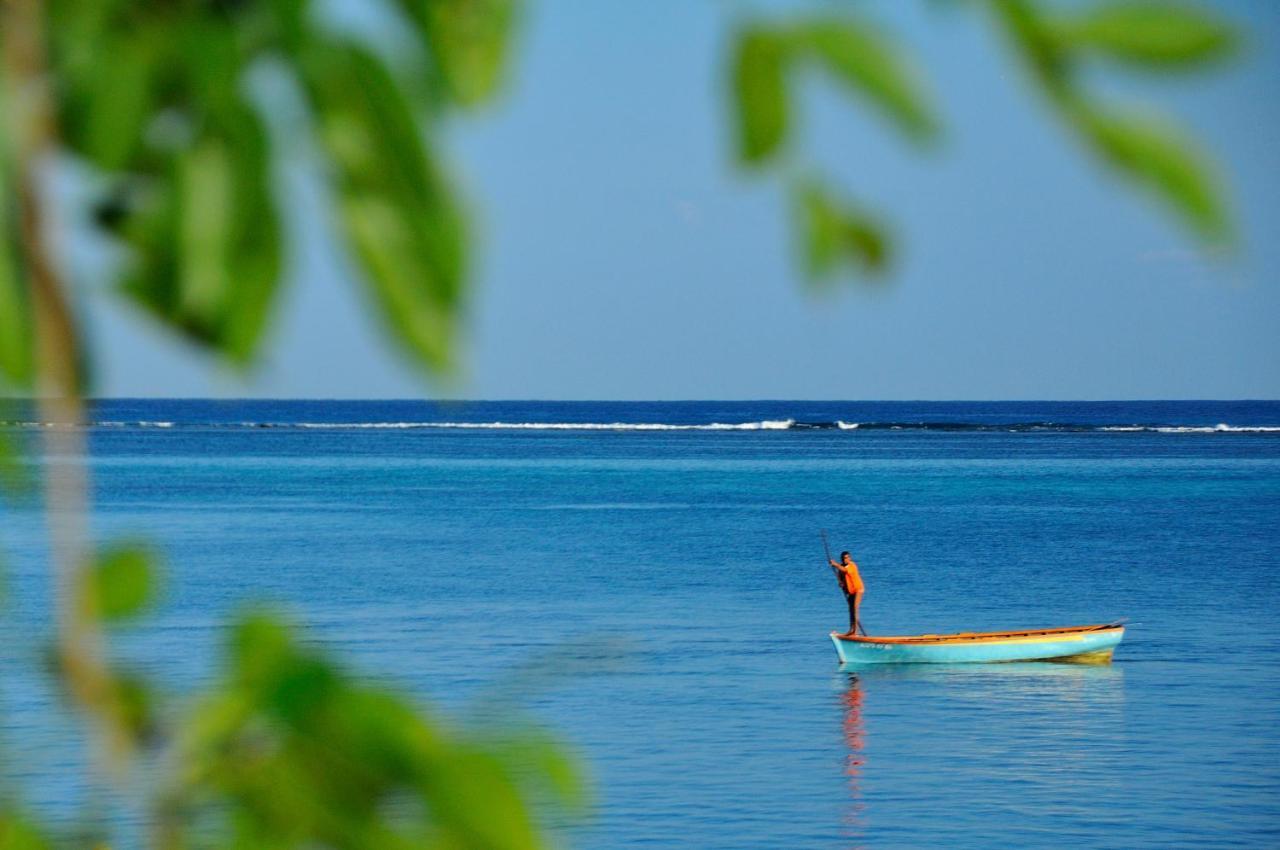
xmin=797 ymin=18 xmax=937 ymax=140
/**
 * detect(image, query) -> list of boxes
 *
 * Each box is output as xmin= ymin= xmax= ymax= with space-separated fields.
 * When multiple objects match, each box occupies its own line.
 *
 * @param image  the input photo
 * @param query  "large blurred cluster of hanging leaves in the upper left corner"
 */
xmin=42 ymin=0 xmax=516 ymax=376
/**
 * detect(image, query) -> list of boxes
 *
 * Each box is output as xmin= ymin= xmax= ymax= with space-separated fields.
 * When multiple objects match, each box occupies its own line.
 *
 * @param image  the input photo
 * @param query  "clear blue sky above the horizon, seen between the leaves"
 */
xmin=87 ymin=0 xmax=1280 ymax=399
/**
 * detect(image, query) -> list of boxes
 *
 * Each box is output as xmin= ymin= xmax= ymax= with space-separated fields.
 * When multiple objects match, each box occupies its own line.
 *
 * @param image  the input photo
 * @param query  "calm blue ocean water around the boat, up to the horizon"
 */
xmin=0 ymin=401 xmax=1280 ymax=849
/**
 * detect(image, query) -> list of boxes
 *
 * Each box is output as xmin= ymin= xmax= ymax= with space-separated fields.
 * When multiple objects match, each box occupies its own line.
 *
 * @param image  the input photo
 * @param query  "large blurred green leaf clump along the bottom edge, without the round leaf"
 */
xmin=160 ymin=614 xmax=582 ymax=850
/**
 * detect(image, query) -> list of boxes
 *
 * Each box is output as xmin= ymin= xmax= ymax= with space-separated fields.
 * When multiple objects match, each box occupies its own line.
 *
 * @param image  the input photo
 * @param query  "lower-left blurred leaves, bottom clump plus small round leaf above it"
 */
xmin=18 ymin=543 xmax=586 ymax=850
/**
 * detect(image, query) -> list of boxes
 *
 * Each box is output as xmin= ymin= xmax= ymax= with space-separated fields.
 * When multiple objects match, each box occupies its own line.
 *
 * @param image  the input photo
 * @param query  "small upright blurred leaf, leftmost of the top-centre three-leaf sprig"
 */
xmin=732 ymin=27 xmax=788 ymax=165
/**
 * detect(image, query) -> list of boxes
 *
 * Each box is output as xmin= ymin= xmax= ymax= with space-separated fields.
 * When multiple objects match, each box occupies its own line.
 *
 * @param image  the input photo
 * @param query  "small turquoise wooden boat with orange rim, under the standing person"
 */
xmin=831 ymin=622 xmax=1124 ymax=664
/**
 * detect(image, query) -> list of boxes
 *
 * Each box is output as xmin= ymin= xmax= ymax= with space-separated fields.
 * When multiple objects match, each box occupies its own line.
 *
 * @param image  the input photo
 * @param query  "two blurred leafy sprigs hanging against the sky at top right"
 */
xmin=731 ymin=0 xmax=1236 ymax=289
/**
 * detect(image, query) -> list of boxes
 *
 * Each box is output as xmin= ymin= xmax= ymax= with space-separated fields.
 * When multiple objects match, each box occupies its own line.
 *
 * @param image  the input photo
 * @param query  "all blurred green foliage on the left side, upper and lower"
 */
xmin=0 ymin=0 xmax=585 ymax=850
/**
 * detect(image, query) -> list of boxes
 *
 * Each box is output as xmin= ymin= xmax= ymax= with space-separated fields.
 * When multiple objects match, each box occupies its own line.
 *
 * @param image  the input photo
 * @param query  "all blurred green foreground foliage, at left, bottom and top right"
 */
xmin=0 ymin=0 xmax=1238 ymax=850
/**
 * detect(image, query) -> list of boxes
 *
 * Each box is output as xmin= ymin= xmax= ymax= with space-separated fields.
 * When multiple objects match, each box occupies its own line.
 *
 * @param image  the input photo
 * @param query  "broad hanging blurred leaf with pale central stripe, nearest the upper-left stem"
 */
xmin=123 ymin=104 xmax=280 ymax=365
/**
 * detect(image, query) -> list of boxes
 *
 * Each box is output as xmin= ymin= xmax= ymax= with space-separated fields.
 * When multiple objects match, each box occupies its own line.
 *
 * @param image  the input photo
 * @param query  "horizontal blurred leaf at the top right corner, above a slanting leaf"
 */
xmin=1056 ymin=0 xmax=1238 ymax=68
